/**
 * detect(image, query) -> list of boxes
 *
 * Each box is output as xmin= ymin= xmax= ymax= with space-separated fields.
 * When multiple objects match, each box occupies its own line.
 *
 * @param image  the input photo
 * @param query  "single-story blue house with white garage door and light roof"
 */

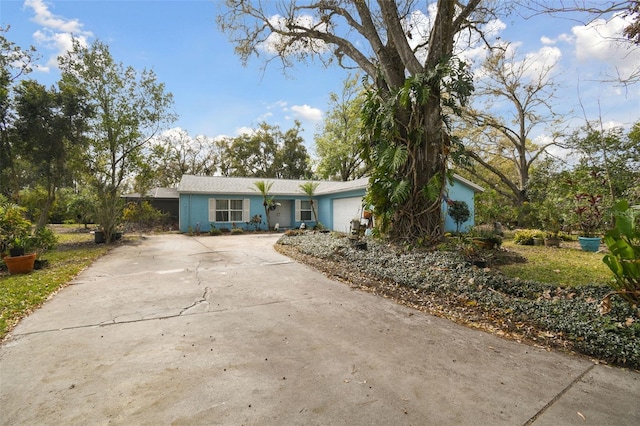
xmin=177 ymin=175 xmax=483 ymax=232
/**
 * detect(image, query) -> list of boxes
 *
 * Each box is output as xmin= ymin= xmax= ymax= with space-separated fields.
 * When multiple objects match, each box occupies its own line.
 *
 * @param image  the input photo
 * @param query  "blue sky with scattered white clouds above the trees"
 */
xmin=0 ymin=0 xmax=640 ymax=153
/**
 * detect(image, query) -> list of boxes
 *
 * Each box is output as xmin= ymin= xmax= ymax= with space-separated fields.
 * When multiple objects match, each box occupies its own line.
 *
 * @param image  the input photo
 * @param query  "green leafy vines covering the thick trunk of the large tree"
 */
xmin=363 ymin=60 xmax=473 ymax=245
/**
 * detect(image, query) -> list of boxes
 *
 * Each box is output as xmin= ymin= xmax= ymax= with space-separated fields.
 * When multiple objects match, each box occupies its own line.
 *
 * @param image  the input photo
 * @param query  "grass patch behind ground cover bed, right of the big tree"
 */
xmin=498 ymin=240 xmax=613 ymax=287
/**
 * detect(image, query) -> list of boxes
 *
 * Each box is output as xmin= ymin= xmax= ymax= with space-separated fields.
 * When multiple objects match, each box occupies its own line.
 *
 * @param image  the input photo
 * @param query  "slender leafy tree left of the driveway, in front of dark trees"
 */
xmin=59 ymin=40 xmax=174 ymax=243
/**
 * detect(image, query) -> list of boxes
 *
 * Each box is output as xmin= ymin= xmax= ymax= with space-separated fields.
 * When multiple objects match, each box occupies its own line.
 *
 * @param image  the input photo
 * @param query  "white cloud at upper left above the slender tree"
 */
xmin=24 ymin=0 xmax=93 ymax=72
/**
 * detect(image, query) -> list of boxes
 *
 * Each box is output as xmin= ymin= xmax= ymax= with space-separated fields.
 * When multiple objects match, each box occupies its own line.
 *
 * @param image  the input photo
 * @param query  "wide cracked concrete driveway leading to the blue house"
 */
xmin=0 ymin=234 xmax=640 ymax=425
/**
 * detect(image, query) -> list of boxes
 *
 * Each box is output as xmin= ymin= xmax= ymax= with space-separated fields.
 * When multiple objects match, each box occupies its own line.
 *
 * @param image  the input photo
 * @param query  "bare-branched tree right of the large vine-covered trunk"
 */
xmin=458 ymin=45 xmax=559 ymax=211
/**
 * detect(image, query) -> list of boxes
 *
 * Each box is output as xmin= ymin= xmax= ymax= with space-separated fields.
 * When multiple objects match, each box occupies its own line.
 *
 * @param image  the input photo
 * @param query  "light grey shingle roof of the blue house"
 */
xmin=177 ymin=175 xmax=484 ymax=196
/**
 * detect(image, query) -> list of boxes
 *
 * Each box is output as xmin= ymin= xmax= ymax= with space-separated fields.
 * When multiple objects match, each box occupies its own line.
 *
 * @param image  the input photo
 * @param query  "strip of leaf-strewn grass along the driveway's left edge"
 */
xmin=0 ymin=233 xmax=109 ymax=340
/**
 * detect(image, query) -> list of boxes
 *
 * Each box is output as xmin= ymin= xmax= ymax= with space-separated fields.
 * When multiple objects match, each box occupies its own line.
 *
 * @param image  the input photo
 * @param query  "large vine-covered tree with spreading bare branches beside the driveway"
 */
xmin=218 ymin=0 xmax=490 ymax=243
